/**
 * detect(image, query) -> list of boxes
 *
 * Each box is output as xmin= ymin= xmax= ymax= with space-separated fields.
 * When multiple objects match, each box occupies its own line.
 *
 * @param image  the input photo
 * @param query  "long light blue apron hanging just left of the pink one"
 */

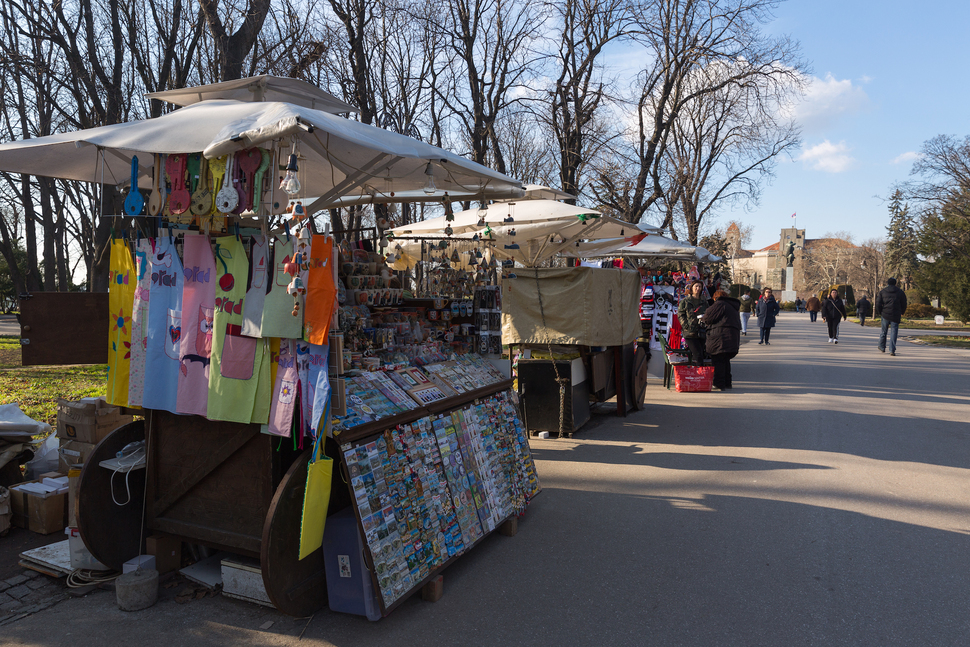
xmin=142 ymin=236 xmax=183 ymax=413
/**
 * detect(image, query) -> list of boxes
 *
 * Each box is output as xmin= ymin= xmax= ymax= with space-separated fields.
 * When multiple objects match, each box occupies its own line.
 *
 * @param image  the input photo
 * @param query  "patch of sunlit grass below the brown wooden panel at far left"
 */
xmin=0 ymin=337 xmax=108 ymax=427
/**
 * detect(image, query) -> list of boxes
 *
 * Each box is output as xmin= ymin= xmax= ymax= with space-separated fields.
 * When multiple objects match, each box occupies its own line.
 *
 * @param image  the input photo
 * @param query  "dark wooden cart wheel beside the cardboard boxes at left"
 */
xmin=77 ymin=420 xmax=145 ymax=571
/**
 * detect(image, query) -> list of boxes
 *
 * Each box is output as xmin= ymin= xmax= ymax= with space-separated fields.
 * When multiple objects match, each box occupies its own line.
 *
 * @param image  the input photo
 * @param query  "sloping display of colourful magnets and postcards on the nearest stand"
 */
xmin=334 ymin=355 xmax=540 ymax=615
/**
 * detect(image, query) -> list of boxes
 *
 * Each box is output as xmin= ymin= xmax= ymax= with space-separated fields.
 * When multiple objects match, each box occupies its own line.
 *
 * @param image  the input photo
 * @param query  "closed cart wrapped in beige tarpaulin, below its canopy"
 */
xmin=502 ymin=267 xmax=647 ymax=437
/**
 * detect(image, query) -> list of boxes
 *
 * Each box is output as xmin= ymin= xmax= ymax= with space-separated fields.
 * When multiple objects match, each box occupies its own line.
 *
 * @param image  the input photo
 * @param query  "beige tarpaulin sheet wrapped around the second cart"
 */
xmin=502 ymin=267 xmax=641 ymax=346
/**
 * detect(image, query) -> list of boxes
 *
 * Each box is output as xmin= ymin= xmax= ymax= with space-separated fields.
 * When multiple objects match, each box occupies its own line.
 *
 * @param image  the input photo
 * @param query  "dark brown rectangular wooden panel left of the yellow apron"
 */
xmin=20 ymin=292 xmax=109 ymax=366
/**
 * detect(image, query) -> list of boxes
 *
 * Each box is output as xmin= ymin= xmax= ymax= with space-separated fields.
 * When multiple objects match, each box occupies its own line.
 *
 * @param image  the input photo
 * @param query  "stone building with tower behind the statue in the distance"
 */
xmin=726 ymin=224 xmax=860 ymax=298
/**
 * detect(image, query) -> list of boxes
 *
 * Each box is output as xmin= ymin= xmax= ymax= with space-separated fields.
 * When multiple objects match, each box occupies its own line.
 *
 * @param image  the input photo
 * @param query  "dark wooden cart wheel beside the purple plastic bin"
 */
xmin=260 ymin=449 xmax=328 ymax=618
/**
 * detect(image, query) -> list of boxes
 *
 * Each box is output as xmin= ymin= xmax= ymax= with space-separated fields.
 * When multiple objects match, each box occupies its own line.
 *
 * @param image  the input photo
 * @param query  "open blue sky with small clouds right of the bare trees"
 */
xmin=740 ymin=0 xmax=970 ymax=249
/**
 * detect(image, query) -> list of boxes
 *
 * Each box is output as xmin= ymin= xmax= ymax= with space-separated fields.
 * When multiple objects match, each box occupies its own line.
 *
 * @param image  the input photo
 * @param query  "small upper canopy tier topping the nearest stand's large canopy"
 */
xmin=145 ymin=74 xmax=357 ymax=114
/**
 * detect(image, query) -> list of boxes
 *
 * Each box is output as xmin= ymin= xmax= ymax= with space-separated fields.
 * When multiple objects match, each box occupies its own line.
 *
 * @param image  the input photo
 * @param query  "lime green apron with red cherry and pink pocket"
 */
xmin=206 ymin=236 xmax=269 ymax=423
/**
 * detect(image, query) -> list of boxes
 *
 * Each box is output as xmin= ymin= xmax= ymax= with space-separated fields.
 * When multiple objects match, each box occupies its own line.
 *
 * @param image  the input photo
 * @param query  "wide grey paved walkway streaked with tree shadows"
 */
xmin=0 ymin=313 xmax=970 ymax=647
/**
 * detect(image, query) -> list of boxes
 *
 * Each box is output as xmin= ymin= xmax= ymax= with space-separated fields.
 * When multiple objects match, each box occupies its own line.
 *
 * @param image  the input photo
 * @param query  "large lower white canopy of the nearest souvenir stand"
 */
xmin=0 ymin=93 xmax=523 ymax=213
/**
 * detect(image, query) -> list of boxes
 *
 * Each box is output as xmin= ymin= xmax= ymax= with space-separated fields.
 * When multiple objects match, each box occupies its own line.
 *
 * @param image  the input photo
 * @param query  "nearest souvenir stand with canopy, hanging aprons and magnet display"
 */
xmin=0 ymin=77 xmax=539 ymax=617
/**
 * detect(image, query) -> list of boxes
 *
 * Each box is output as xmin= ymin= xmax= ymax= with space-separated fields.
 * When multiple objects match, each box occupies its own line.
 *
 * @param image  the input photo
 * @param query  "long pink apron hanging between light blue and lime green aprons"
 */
xmin=176 ymin=234 xmax=217 ymax=416
